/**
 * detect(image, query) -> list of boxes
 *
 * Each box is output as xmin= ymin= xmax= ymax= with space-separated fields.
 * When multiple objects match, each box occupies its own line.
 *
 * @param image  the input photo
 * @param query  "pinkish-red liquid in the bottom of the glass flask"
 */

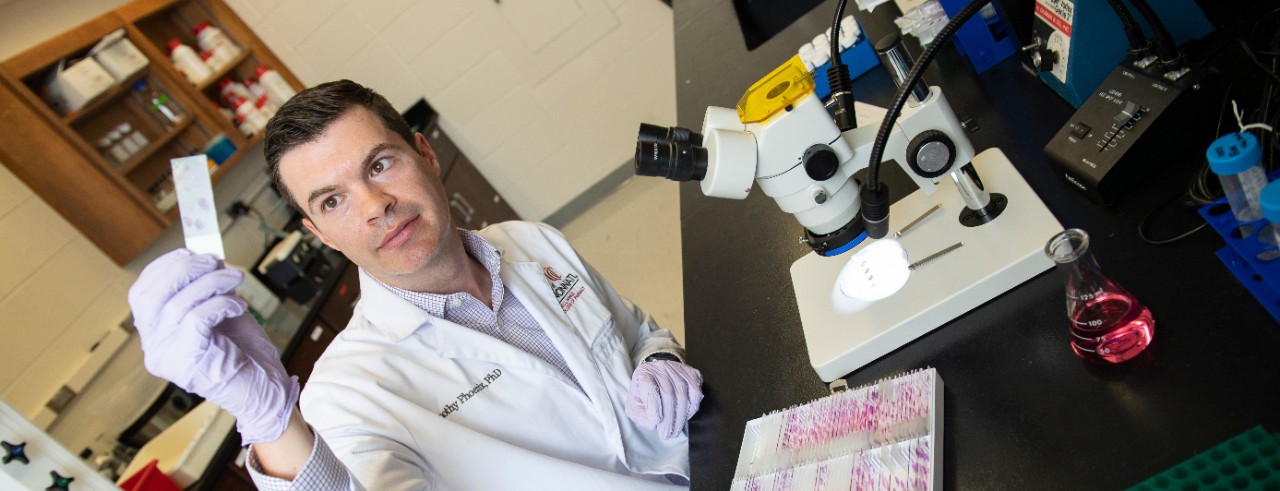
xmin=1071 ymin=292 xmax=1156 ymax=363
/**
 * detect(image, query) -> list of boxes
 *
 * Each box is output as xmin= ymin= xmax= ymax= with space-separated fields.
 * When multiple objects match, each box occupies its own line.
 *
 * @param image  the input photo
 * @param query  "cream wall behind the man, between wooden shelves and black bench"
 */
xmin=227 ymin=0 xmax=680 ymax=220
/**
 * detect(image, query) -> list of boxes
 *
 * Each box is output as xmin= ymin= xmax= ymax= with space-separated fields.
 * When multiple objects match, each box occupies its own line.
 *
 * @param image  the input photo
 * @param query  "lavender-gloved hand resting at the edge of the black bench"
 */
xmin=627 ymin=359 xmax=703 ymax=440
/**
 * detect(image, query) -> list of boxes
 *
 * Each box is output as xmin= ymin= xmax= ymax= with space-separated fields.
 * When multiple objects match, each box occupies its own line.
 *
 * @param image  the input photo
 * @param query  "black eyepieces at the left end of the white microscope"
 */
xmin=635 ymin=123 xmax=707 ymax=182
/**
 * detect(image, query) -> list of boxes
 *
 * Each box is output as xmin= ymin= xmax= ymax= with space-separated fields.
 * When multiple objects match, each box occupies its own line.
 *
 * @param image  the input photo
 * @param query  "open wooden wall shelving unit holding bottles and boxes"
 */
xmin=0 ymin=0 xmax=302 ymax=265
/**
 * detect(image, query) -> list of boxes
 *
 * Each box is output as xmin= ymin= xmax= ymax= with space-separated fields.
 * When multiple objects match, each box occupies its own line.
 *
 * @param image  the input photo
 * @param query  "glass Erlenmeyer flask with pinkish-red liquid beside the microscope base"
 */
xmin=1044 ymin=229 xmax=1156 ymax=363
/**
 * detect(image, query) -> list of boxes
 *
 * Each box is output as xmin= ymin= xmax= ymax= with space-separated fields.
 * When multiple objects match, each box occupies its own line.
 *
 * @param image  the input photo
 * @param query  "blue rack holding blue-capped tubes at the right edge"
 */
xmin=1199 ymin=189 xmax=1280 ymax=322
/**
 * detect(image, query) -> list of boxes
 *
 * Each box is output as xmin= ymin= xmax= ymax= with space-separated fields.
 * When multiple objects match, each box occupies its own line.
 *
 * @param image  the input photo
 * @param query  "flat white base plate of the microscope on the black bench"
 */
xmin=791 ymin=148 xmax=1062 ymax=382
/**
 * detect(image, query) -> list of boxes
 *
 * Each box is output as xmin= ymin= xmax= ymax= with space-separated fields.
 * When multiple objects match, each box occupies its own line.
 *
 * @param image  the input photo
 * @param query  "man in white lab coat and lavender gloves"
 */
xmin=129 ymin=81 xmax=701 ymax=490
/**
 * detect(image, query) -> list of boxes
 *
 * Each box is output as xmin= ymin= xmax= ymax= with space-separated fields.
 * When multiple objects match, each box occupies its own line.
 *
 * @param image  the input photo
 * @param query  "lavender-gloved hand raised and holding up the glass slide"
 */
xmin=129 ymin=249 xmax=298 ymax=444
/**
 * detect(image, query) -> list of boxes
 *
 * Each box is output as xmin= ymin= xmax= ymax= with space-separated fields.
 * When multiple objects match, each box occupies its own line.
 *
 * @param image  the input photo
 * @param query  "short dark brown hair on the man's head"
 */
xmin=262 ymin=79 xmax=413 ymax=215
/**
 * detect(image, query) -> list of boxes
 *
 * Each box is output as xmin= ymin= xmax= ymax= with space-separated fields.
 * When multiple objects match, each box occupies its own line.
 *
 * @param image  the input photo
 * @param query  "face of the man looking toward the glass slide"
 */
xmin=279 ymin=107 xmax=456 ymax=285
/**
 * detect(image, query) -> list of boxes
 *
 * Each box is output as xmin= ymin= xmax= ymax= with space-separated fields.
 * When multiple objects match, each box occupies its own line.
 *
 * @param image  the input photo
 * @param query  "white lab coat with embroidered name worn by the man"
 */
xmin=301 ymin=222 xmax=689 ymax=490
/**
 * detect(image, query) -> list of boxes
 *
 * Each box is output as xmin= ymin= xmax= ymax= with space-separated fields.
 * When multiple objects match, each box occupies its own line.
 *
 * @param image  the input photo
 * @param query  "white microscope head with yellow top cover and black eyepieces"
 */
xmin=635 ymin=56 xmax=865 ymax=256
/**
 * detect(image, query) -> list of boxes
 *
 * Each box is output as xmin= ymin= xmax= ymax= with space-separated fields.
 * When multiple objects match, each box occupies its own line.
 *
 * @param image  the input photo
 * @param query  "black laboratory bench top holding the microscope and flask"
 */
xmin=675 ymin=0 xmax=1280 ymax=490
